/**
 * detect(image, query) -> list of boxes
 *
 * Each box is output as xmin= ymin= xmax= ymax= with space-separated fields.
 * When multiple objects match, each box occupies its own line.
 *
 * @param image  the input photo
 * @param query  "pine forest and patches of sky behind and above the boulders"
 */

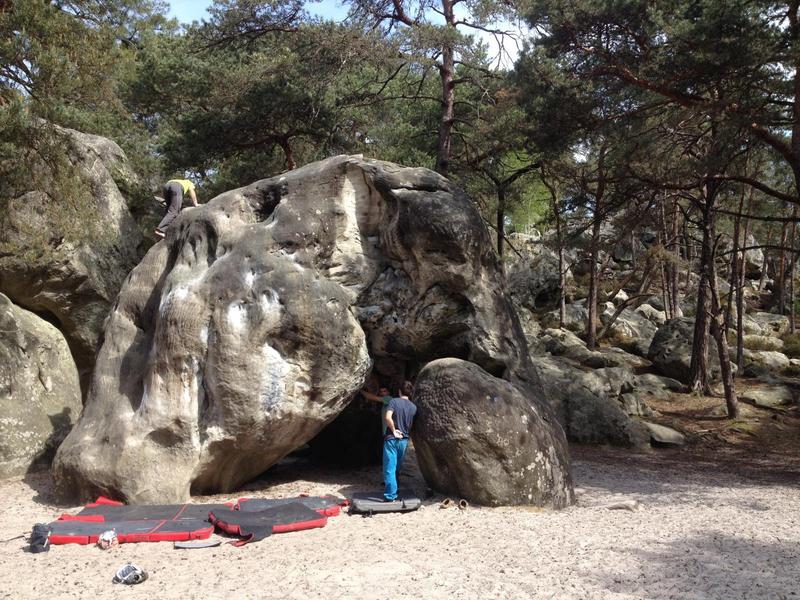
xmin=0 ymin=0 xmax=800 ymax=416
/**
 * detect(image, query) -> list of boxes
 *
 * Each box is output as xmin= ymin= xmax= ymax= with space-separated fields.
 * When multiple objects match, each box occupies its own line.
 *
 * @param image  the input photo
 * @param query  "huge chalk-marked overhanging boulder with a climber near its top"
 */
xmin=54 ymin=157 xmax=542 ymax=502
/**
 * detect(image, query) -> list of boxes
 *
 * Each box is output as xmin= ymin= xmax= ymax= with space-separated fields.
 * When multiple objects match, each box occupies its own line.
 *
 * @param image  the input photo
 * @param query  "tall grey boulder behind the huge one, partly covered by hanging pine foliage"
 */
xmin=0 ymin=128 xmax=142 ymax=391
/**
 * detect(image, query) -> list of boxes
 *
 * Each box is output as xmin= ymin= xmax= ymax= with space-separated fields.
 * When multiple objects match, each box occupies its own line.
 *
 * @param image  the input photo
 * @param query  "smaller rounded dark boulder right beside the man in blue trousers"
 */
xmin=412 ymin=358 xmax=574 ymax=508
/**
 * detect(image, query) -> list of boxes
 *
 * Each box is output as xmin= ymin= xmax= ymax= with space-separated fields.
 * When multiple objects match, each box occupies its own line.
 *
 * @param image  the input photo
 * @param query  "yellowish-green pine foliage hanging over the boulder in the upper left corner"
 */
xmin=0 ymin=0 xmax=166 ymax=253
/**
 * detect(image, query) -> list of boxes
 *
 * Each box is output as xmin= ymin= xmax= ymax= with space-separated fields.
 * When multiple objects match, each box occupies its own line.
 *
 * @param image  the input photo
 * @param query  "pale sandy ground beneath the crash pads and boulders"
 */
xmin=0 ymin=450 xmax=800 ymax=600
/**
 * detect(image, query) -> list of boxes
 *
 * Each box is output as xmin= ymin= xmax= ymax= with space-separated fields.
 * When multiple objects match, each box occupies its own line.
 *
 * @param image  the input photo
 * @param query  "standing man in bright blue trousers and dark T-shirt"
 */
xmin=383 ymin=381 xmax=417 ymax=502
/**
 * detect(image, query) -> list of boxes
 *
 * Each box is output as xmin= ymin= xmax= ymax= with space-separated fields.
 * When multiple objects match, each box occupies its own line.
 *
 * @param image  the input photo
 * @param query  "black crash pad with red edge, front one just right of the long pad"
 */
xmin=208 ymin=502 xmax=328 ymax=546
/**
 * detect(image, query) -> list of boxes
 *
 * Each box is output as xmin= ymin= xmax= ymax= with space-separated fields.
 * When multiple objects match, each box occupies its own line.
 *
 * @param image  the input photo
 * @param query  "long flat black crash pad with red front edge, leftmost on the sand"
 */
xmin=48 ymin=519 xmax=214 ymax=544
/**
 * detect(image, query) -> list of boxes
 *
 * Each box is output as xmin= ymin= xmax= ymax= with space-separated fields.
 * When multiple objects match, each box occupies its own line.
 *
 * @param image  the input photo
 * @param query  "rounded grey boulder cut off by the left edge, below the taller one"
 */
xmin=0 ymin=294 xmax=81 ymax=478
